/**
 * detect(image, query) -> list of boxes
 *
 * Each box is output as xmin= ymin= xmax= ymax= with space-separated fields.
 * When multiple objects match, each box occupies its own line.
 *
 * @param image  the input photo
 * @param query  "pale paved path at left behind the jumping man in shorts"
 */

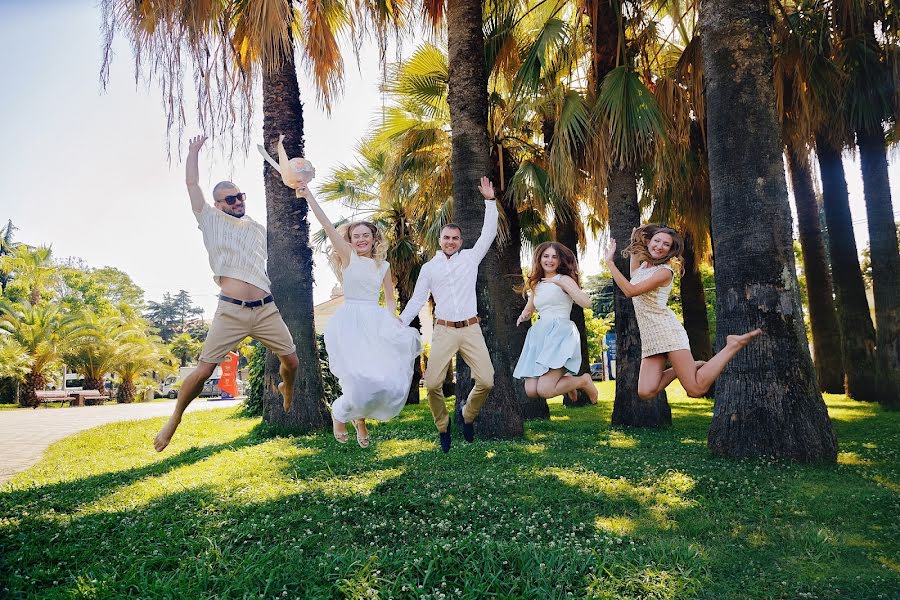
xmin=0 ymin=399 xmax=243 ymax=484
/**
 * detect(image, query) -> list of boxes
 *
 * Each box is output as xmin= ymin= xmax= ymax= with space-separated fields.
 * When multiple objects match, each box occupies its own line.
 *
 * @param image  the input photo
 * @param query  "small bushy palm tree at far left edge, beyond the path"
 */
xmin=0 ymin=298 xmax=86 ymax=406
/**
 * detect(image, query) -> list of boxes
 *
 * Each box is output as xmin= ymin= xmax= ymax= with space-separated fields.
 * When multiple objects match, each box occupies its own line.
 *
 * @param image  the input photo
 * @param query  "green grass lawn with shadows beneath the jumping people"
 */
xmin=0 ymin=383 xmax=900 ymax=599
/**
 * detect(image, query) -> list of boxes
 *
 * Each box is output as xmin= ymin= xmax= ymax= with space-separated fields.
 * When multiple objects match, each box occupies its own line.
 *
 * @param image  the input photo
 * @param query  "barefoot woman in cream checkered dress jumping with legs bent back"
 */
xmin=606 ymin=223 xmax=762 ymax=400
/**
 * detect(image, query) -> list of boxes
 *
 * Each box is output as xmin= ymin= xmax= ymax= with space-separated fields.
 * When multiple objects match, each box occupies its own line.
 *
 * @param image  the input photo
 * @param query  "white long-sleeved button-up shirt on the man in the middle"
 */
xmin=400 ymin=200 xmax=497 ymax=325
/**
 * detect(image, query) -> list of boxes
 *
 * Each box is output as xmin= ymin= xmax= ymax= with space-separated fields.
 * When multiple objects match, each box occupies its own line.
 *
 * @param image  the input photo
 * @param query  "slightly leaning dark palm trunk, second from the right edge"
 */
xmin=816 ymin=133 xmax=878 ymax=401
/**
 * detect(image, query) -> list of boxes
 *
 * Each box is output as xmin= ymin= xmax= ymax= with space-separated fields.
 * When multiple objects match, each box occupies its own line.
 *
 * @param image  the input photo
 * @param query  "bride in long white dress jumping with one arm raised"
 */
xmin=298 ymin=189 xmax=422 ymax=448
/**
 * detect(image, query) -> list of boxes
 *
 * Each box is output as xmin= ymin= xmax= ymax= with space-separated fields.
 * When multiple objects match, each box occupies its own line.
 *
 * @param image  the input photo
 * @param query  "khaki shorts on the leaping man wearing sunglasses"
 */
xmin=200 ymin=300 xmax=297 ymax=364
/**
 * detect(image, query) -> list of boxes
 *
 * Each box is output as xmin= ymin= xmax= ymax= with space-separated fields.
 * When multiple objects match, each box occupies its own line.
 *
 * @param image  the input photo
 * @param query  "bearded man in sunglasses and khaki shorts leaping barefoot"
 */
xmin=153 ymin=135 xmax=299 ymax=452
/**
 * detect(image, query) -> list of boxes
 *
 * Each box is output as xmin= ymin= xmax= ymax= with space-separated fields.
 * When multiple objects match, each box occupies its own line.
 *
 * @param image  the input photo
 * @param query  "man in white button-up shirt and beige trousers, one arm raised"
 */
xmin=400 ymin=177 xmax=497 ymax=452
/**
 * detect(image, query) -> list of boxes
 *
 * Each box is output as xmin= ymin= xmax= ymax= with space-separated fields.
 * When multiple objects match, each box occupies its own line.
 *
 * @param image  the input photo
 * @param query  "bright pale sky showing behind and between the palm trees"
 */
xmin=0 ymin=0 xmax=900 ymax=316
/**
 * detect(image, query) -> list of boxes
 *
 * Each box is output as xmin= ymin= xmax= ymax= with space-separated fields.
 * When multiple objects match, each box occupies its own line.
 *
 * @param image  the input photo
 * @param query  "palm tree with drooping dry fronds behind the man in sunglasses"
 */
xmin=101 ymin=0 xmax=400 ymax=431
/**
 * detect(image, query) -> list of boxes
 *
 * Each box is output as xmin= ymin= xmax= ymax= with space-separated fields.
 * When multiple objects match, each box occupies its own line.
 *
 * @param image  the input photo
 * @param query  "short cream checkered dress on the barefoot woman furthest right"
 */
xmin=631 ymin=263 xmax=691 ymax=358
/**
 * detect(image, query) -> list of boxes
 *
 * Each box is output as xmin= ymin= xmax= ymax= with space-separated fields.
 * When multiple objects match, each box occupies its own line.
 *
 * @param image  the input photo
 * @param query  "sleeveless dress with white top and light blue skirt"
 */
xmin=513 ymin=281 xmax=581 ymax=379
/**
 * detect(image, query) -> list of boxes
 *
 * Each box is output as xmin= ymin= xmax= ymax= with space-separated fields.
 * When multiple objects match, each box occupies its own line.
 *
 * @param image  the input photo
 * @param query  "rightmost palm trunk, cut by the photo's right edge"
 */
xmin=856 ymin=129 xmax=900 ymax=410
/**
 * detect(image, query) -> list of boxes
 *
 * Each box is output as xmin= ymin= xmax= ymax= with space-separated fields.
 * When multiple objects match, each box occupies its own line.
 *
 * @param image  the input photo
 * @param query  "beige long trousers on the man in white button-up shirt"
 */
xmin=425 ymin=324 xmax=494 ymax=431
